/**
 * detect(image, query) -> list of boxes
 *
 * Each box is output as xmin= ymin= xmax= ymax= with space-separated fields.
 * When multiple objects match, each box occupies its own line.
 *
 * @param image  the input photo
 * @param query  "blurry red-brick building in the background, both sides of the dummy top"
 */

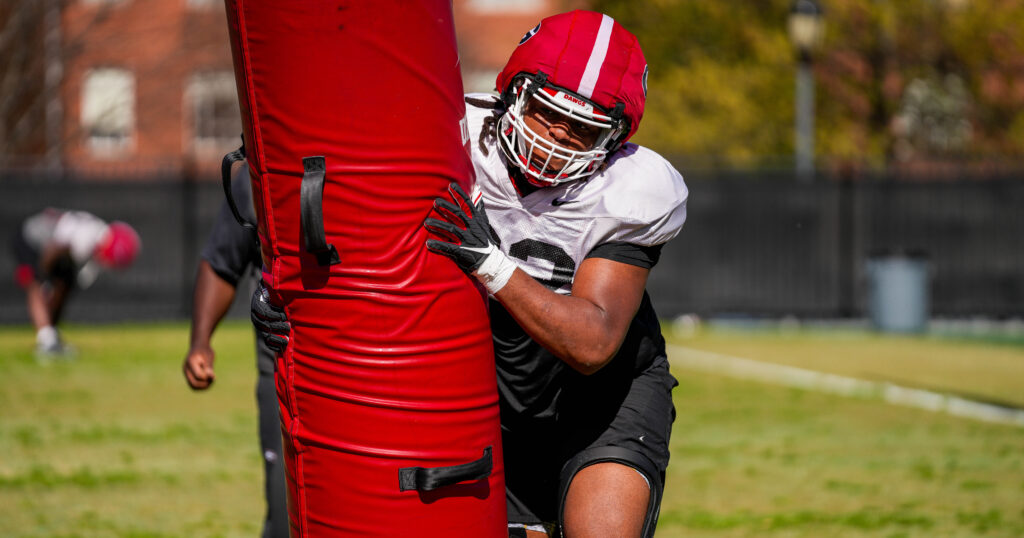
xmin=54 ymin=0 xmax=582 ymax=177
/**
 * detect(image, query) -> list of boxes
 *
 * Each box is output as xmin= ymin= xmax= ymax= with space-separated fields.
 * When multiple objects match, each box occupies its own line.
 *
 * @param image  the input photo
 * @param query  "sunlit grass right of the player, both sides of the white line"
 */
xmin=658 ymin=323 xmax=1024 ymax=538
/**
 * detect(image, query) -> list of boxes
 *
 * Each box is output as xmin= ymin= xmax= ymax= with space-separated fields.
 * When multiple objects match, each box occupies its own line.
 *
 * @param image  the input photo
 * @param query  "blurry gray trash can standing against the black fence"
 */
xmin=867 ymin=250 xmax=930 ymax=333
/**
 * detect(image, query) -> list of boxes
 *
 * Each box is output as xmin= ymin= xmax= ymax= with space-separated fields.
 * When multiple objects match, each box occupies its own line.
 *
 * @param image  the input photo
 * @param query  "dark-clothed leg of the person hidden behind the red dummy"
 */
xmin=256 ymin=338 xmax=289 ymax=538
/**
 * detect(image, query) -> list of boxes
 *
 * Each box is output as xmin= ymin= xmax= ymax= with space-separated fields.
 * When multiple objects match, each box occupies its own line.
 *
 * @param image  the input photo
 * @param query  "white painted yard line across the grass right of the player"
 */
xmin=668 ymin=344 xmax=1024 ymax=426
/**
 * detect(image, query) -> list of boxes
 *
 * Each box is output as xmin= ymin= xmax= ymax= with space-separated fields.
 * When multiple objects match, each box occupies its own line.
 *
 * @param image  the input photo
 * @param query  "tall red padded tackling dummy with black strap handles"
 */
xmin=226 ymin=0 xmax=507 ymax=538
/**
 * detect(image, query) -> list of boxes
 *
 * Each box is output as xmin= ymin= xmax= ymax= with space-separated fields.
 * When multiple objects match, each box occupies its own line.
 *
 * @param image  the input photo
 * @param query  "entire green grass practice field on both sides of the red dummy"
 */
xmin=0 ymin=322 xmax=1024 ymax=538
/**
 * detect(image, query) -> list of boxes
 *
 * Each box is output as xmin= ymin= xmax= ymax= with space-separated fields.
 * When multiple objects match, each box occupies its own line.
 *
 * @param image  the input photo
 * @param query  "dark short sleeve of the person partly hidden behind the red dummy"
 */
xmin=201 ymin=166 xmax=260 ymax=286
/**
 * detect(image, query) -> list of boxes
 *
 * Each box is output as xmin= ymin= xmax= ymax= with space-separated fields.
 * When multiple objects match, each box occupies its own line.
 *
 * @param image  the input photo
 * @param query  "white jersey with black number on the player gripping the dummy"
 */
xmin=466 ymin=94 xmax=688 ymax=294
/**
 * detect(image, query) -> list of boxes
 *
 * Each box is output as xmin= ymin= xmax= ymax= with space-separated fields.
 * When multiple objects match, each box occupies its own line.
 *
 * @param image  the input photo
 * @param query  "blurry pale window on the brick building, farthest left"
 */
xmin=82 ymin=68 xmax=135 ymax=154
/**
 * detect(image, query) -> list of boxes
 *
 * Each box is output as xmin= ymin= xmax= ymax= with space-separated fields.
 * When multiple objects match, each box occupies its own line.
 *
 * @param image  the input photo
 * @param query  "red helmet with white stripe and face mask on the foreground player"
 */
xmin=497 ymin=10 xmax=647 ymax=187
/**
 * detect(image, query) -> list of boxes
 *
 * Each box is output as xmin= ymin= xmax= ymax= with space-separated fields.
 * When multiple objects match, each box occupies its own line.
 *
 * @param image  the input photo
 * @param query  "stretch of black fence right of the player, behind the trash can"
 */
xmin=649 ymin=173 xmax=1024 ymax=318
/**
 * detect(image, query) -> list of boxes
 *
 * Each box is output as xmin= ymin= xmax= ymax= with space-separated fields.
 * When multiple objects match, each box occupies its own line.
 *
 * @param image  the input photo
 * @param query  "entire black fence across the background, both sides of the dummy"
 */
xmin=0 ymin=166 xmax=1024 ymax=323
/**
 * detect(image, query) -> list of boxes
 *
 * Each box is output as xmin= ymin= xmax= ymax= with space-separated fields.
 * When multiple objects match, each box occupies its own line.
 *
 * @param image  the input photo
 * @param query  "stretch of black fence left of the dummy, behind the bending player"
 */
xmin=0 ymin=167 xmax=238 ymax=323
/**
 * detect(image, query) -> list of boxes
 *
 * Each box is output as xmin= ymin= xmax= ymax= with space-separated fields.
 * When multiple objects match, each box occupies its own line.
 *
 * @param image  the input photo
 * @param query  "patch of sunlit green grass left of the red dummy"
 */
xmin=0 ymin=323 xmax=263 ymax=537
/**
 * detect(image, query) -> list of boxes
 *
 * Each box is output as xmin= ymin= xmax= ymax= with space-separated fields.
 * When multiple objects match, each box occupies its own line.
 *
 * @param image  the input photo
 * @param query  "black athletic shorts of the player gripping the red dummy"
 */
xmin=502 ymin=357 xmax=678 ymax=525
